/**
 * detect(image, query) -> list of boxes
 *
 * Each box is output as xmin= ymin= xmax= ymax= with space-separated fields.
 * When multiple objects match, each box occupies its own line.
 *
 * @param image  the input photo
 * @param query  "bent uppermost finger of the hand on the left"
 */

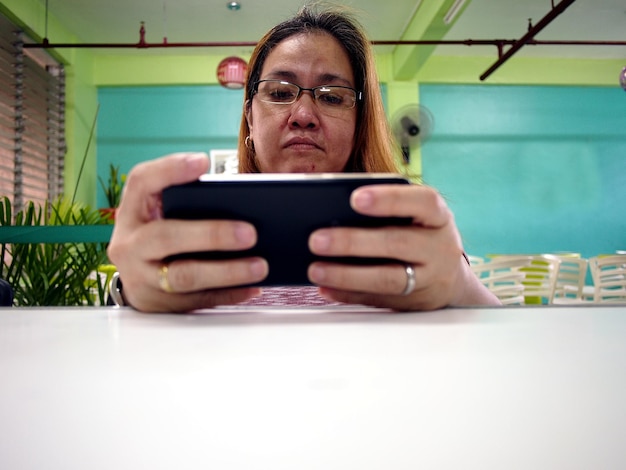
xmin=116 ymin=153 xmax=209 ymax=226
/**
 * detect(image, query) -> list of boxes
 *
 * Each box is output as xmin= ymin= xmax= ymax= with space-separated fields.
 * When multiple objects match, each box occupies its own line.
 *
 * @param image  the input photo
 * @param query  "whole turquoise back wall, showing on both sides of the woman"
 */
xmin=97 ymin=84 xmax=626 ymax=257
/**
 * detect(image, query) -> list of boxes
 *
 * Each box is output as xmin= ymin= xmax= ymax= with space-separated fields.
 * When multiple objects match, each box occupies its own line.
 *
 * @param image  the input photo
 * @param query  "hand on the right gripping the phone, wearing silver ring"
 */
xmin=308 ymin=185 xmax=499 ymax=310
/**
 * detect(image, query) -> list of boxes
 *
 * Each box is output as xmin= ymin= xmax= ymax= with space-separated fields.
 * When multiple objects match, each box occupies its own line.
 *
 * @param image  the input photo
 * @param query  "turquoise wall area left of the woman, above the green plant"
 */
xmin=97 ymin=85 xmax=243 ymax=207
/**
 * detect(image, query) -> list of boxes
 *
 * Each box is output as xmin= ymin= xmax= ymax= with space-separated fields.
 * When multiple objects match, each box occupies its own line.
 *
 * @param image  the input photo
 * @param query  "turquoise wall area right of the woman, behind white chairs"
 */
xmin=419 ymin=85 xmax=626 ymax=257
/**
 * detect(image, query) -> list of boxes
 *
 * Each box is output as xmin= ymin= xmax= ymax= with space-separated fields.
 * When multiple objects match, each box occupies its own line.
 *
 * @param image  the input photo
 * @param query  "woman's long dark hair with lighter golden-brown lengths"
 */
xmin=238 ymin=6 xmax=398 ymax=173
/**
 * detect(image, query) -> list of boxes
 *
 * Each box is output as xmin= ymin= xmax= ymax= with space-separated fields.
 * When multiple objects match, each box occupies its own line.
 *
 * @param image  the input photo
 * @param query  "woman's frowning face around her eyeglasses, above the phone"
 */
xmin=246 ymin=33 xmax=358 ymax=173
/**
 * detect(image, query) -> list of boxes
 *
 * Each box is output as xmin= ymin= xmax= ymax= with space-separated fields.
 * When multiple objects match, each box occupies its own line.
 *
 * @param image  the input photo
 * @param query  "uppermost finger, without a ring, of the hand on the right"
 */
xmin=350 ymin=184 xmax=452 ymax=228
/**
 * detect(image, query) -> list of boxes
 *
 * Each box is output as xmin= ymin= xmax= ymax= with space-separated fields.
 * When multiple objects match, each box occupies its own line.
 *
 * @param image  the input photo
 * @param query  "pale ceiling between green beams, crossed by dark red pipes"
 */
xmin=33 ymin=0 xmax=626 ymax=62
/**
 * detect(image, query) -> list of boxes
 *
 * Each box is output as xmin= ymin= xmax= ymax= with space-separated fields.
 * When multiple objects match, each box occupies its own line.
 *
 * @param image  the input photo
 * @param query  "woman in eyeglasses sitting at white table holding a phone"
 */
xmin=109 ymin=7 xmax=499 ymax=311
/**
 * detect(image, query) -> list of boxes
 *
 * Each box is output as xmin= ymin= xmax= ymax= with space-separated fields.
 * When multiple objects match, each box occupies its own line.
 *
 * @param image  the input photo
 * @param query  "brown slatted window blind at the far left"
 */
xmin=0 ymin=15 xmax=66 ymax=211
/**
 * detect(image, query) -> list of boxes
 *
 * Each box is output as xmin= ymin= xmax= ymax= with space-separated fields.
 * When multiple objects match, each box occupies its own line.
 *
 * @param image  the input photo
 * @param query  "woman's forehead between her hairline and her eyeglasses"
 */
xmin=261 ymin=31 xmax=354 ymax=85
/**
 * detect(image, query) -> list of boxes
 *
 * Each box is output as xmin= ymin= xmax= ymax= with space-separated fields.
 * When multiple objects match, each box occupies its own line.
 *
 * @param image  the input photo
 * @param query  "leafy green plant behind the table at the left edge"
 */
xmin=0 ymin=197 xmax=108 ymax=306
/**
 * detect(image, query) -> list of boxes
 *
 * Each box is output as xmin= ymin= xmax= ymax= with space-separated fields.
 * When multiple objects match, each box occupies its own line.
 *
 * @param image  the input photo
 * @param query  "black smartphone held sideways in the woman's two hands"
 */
xmin=163 ymin=173 xmax=411 ymax=286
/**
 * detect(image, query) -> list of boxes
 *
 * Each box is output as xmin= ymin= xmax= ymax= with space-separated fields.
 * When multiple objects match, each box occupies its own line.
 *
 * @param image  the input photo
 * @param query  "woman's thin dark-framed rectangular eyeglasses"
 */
xmin=253 ymin=80 xmax=362 ymax=110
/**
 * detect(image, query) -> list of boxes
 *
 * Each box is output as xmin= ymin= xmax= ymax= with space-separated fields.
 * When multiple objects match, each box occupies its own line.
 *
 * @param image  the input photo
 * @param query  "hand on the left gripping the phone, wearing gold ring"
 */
xmin=108 ymin=153 xmax=268 ymax=312
